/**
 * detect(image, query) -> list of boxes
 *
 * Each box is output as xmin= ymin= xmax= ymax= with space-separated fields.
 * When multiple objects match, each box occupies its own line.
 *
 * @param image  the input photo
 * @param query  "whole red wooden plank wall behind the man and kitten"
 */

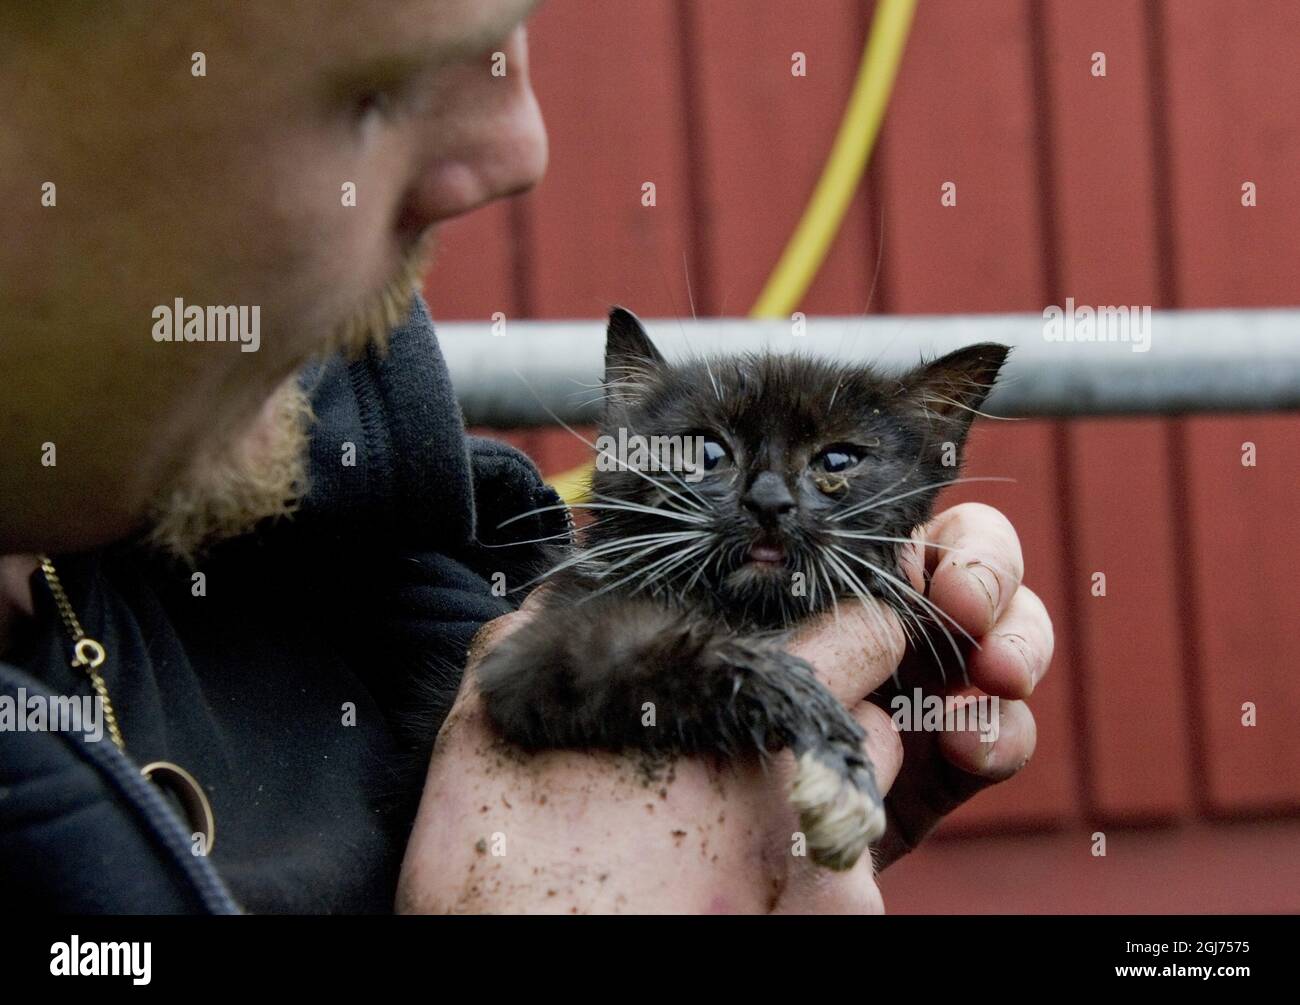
xmin=428 ymin=0 xmax=1300 ymax=911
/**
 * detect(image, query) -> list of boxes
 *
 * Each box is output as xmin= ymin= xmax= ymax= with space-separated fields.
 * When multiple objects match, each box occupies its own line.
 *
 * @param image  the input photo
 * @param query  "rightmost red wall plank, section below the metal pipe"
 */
xmin=1187 ymin=415 xmax=1300 ymax=814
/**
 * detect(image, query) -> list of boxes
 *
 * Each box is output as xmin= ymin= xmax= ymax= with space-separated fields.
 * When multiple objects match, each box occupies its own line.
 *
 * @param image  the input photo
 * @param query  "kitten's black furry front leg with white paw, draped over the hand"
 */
xmin=478 ymin=598 xmax=885 ymax=870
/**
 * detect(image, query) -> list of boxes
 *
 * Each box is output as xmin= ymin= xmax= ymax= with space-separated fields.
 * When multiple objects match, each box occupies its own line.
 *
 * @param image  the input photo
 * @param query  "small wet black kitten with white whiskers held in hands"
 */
xmin=478 ymin=308 xmax=1008 ymax=868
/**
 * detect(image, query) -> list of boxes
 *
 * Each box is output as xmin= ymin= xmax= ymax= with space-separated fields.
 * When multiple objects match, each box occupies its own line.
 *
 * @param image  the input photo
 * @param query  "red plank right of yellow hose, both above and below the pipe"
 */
xmin=880 ymin=0 xmax=1079 ymax=832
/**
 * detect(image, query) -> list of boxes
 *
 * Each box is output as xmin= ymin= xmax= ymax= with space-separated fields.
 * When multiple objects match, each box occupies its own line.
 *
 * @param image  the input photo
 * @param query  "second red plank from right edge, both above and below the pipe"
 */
xmin=1034 ymin=0 xmax=1192 ymax=820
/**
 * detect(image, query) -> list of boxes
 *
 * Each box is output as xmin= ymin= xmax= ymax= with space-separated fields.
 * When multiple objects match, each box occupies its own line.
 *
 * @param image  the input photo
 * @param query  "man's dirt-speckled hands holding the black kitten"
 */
xmin=398 ymin=504 xmax=1052 ymax=913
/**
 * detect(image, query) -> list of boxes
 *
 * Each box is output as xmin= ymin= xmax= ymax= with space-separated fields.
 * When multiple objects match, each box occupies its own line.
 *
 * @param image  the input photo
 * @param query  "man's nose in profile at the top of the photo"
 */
xmin=403 ymin=27 xmax=547 ymax=231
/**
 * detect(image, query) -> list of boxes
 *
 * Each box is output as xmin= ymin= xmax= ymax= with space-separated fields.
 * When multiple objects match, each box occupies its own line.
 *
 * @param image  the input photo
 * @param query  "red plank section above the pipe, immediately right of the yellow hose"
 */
xmin=880 ymin=0 xmax=1043 ymax=313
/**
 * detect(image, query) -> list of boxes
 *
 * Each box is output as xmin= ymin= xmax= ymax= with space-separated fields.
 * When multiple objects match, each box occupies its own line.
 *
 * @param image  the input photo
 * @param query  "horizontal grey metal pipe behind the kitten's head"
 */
xmin=438 ymin=302 xmax=1300 ymax=428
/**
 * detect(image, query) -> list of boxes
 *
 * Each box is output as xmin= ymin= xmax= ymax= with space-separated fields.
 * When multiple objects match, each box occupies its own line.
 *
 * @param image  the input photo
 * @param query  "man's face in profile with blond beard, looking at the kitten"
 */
xmin=0 ymin=0 xmax=546 ymax=555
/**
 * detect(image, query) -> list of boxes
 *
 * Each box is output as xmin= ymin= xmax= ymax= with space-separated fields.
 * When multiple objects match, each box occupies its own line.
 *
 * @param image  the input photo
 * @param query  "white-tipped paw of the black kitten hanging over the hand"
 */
xmin=790 ymin=750 xmax=885 ymax=870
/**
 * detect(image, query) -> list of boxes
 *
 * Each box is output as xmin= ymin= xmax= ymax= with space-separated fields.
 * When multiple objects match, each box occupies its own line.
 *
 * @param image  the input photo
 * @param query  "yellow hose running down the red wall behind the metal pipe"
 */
xmin=550 ymin=0 xmax=917 ymax=503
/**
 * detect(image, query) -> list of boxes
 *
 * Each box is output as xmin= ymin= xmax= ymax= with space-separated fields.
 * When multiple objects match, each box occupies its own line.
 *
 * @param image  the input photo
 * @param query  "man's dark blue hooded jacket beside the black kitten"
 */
xmin=0 ymin=302 xmax=566 ymax=913
